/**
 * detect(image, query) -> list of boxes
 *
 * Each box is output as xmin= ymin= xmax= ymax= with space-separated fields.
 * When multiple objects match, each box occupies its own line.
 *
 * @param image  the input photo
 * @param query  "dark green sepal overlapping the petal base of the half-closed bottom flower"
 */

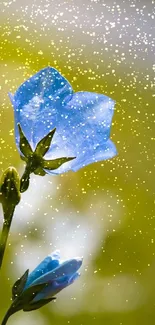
xmin=19 ymin=283 xmax=48 ymax=306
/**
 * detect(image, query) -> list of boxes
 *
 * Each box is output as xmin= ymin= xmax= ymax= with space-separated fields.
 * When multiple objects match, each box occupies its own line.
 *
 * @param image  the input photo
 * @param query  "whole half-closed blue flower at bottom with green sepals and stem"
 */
xmin=4 ymin=251 xmax=82 ymax=323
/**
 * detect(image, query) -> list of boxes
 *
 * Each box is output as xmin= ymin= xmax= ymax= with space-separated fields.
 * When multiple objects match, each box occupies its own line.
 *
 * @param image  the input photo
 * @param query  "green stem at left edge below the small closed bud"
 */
xmin=0 ymin=206 xmax=15 ymax=269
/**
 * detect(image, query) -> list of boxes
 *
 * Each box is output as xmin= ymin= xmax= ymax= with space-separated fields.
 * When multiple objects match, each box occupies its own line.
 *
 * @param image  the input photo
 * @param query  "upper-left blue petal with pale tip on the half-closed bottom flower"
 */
xmin=24 ymin=251 xmax=60 ymax=289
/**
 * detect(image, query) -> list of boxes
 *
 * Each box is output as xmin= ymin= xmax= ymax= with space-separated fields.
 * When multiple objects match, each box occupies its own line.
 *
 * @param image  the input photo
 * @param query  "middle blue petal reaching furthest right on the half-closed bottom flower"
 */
xmin=31 ymin=258 xmax=82 ymax=285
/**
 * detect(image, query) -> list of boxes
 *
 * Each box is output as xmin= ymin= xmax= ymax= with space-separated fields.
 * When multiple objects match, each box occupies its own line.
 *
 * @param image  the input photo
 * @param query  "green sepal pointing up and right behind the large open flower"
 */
xmin=35 ymin=128 xmax=56 ymax=157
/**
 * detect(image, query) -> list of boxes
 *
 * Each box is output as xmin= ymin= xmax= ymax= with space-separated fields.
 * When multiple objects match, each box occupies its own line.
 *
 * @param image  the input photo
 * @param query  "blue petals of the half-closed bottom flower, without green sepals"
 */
xmin=24 ymin=251 xmax=82 ymax=305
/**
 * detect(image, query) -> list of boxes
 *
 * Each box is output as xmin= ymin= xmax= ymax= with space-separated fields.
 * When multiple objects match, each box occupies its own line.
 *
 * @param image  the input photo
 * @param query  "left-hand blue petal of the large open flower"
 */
xmin=10 ymin=67 xmax=72 ymax=149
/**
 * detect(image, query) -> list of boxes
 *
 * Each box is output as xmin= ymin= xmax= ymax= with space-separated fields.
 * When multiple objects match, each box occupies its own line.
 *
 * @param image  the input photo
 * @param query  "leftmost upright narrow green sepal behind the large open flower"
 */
xmin=18 ymin=123 xmax=33 ymax=158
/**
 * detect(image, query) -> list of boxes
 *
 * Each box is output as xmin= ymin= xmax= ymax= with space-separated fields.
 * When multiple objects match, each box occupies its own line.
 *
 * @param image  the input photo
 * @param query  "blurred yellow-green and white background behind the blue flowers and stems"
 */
xmin=0 ymin=1 xmax=155 ymax=325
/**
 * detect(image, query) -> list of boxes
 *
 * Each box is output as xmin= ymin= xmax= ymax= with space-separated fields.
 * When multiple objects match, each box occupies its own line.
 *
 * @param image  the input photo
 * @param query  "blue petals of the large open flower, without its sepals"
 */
xmin=10 ymin=67 xmax=117 ymax=174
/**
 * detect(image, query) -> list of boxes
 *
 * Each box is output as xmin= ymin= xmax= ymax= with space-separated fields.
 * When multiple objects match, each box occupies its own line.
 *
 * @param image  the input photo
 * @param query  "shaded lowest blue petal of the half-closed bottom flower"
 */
xmin=33 ymin=272 xmax=80 ymax=302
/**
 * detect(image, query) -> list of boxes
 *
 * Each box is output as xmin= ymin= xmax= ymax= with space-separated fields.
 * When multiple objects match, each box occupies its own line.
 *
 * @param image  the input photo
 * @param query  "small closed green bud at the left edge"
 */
xmin=0 ymin=167 xmax=20 ymax=208
